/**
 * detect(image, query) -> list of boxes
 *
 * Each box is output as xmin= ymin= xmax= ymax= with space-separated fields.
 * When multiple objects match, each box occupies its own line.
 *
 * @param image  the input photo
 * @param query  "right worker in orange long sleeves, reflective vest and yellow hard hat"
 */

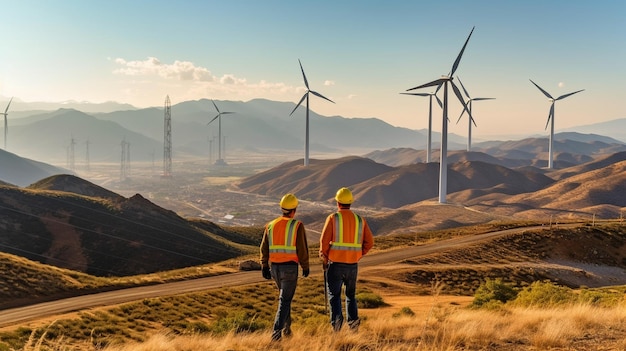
xmin=320 ymin=188 xmax=374 ymax=331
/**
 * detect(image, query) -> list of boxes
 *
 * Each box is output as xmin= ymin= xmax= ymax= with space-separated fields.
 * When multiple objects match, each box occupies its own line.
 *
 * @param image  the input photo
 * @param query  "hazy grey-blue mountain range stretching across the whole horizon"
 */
xmin=0 ymin=99 xmax=626 ymax=164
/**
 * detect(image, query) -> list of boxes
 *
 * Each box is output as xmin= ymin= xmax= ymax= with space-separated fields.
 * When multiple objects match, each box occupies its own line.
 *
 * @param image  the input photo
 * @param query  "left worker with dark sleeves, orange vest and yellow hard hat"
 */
xmin=261 ymin=194 xmax=309 ymax=341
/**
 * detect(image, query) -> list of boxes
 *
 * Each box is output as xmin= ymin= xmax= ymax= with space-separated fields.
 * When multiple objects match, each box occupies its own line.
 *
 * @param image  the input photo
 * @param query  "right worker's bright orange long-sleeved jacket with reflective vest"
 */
xmin=320 ymin=209 xmax=374 ymax=263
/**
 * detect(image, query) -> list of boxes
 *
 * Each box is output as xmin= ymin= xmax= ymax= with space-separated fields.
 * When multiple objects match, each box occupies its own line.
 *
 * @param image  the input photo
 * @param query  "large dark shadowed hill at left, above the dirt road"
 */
xmin=0 ymin=175 xmax=258 ymax=276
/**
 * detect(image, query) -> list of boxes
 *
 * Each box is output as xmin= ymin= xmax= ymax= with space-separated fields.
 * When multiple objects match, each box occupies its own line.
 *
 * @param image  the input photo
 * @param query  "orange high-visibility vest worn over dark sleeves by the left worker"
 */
xmin=266 ymin=217 xmax=300 ymax=263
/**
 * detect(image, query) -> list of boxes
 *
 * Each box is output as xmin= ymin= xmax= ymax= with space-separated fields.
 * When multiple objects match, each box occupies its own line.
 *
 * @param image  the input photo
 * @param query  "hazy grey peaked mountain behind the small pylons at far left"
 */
xmin=9 ymin=109 xmax=163 ymax=163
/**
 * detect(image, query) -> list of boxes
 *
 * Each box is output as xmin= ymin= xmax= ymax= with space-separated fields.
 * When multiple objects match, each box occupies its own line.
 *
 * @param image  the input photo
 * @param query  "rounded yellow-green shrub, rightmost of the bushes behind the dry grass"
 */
xmin=512 ymin=281 xmax=577 ymax=307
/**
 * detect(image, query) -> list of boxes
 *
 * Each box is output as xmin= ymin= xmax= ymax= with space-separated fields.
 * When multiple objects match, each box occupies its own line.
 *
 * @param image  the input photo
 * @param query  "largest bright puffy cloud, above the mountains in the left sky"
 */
xmin=113 ymin=57 xmax=216 ymax=82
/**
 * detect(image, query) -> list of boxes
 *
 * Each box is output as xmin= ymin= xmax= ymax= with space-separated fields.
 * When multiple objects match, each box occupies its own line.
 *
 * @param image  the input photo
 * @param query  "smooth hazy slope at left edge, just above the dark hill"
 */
xmin=0 ymin=150 xmax=70 ymax=186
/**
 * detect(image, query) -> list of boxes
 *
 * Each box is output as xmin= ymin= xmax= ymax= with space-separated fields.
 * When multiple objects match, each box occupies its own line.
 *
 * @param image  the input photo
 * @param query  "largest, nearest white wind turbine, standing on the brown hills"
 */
xmin=406 ymin=28 xmax=474 ymax=204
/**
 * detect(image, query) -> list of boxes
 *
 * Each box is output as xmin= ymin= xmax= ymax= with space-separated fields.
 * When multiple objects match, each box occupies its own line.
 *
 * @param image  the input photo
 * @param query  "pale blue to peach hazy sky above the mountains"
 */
xmin=0 ymin=0 xmax=626 ymax=139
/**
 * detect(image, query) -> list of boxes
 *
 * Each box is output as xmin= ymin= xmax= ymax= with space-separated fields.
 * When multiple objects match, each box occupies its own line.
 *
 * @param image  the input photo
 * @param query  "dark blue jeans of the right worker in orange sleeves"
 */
xmin=326 ymin=262 xmax=359 ymax=331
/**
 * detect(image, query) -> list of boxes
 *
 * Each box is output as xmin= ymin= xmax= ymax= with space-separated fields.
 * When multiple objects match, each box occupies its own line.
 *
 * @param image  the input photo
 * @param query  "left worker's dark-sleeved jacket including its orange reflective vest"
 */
xmin=261 ymin=216 xmax=309 ymax=269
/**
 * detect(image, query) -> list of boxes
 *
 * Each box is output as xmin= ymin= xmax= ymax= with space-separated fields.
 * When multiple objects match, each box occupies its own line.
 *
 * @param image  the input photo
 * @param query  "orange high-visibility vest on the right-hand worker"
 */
xmin=328 ymin=212 xmax=363 ymax=263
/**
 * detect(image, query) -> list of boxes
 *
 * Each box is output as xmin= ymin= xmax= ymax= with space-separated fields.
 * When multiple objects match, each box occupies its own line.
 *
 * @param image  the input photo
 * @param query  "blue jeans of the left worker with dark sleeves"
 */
xmin=271 ymin=263 xmax=298 ymax=340
